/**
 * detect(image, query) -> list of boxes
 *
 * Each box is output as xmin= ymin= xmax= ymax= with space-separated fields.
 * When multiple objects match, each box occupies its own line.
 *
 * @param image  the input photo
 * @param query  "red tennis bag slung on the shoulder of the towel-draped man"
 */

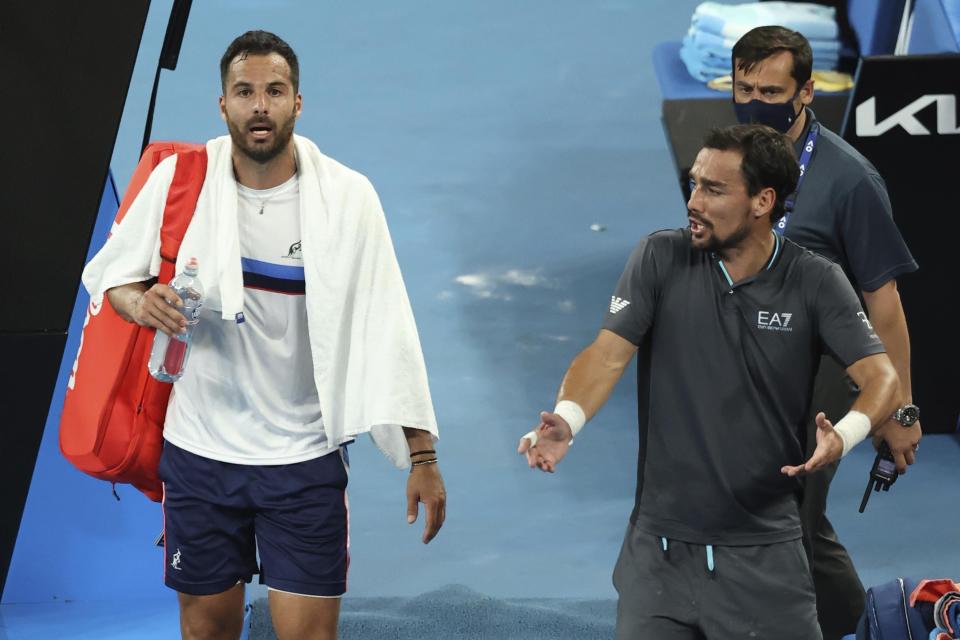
xmin=60 ymin=142 xmax=207 ymax=502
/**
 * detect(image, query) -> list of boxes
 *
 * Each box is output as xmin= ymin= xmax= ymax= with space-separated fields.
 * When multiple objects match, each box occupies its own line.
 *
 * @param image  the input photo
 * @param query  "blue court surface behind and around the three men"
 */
xmin=0 ymin=0 xmax=960 ymax=640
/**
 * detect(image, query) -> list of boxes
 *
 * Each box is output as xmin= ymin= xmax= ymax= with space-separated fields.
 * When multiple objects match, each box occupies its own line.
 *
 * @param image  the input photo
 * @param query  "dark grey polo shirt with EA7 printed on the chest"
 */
xmin=603 ymin=229 xmax=884 ymax=545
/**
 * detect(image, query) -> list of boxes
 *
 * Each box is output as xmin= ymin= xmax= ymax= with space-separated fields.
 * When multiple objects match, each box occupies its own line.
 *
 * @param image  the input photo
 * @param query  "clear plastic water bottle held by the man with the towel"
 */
xmin=148 ymin=258 xmax=203 ymax=382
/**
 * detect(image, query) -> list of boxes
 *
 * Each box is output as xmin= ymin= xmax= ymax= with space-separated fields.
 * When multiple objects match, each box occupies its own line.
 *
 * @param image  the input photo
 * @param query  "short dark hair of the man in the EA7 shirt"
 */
xmin=703 ymin=124 xmax=800 ymax=223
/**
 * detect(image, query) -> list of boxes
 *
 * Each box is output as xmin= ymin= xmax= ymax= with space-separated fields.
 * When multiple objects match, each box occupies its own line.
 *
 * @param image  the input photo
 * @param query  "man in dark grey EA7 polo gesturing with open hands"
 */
xmin=519 ymin=125 xmax=914 ymax=640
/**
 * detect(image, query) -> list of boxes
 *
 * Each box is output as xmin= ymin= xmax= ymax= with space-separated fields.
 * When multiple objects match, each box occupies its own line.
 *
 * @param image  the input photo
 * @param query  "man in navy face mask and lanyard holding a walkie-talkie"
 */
xmin=733 ymin=26 xmax=920 ymax=640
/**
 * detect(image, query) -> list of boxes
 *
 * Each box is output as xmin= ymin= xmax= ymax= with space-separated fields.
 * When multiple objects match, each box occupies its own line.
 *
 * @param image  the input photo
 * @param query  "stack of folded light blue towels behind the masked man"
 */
xmin=680 ymin=2 xmax=840 ymax=82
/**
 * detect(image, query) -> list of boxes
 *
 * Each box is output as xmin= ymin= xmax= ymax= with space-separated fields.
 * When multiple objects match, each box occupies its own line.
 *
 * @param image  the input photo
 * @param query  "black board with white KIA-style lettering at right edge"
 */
xmin=843 ymin=54 xmax=960 ymax=433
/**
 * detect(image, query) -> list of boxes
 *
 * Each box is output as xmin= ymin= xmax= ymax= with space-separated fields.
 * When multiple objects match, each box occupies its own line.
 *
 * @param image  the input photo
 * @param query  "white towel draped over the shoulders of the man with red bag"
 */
xmin=83 ymin=136 xmax=438 ymax=468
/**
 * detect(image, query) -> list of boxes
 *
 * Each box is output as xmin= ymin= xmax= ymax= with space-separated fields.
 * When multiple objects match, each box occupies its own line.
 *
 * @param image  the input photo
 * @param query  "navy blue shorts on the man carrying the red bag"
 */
xmin=160 ymin=442 xmax=350 ymax=597
